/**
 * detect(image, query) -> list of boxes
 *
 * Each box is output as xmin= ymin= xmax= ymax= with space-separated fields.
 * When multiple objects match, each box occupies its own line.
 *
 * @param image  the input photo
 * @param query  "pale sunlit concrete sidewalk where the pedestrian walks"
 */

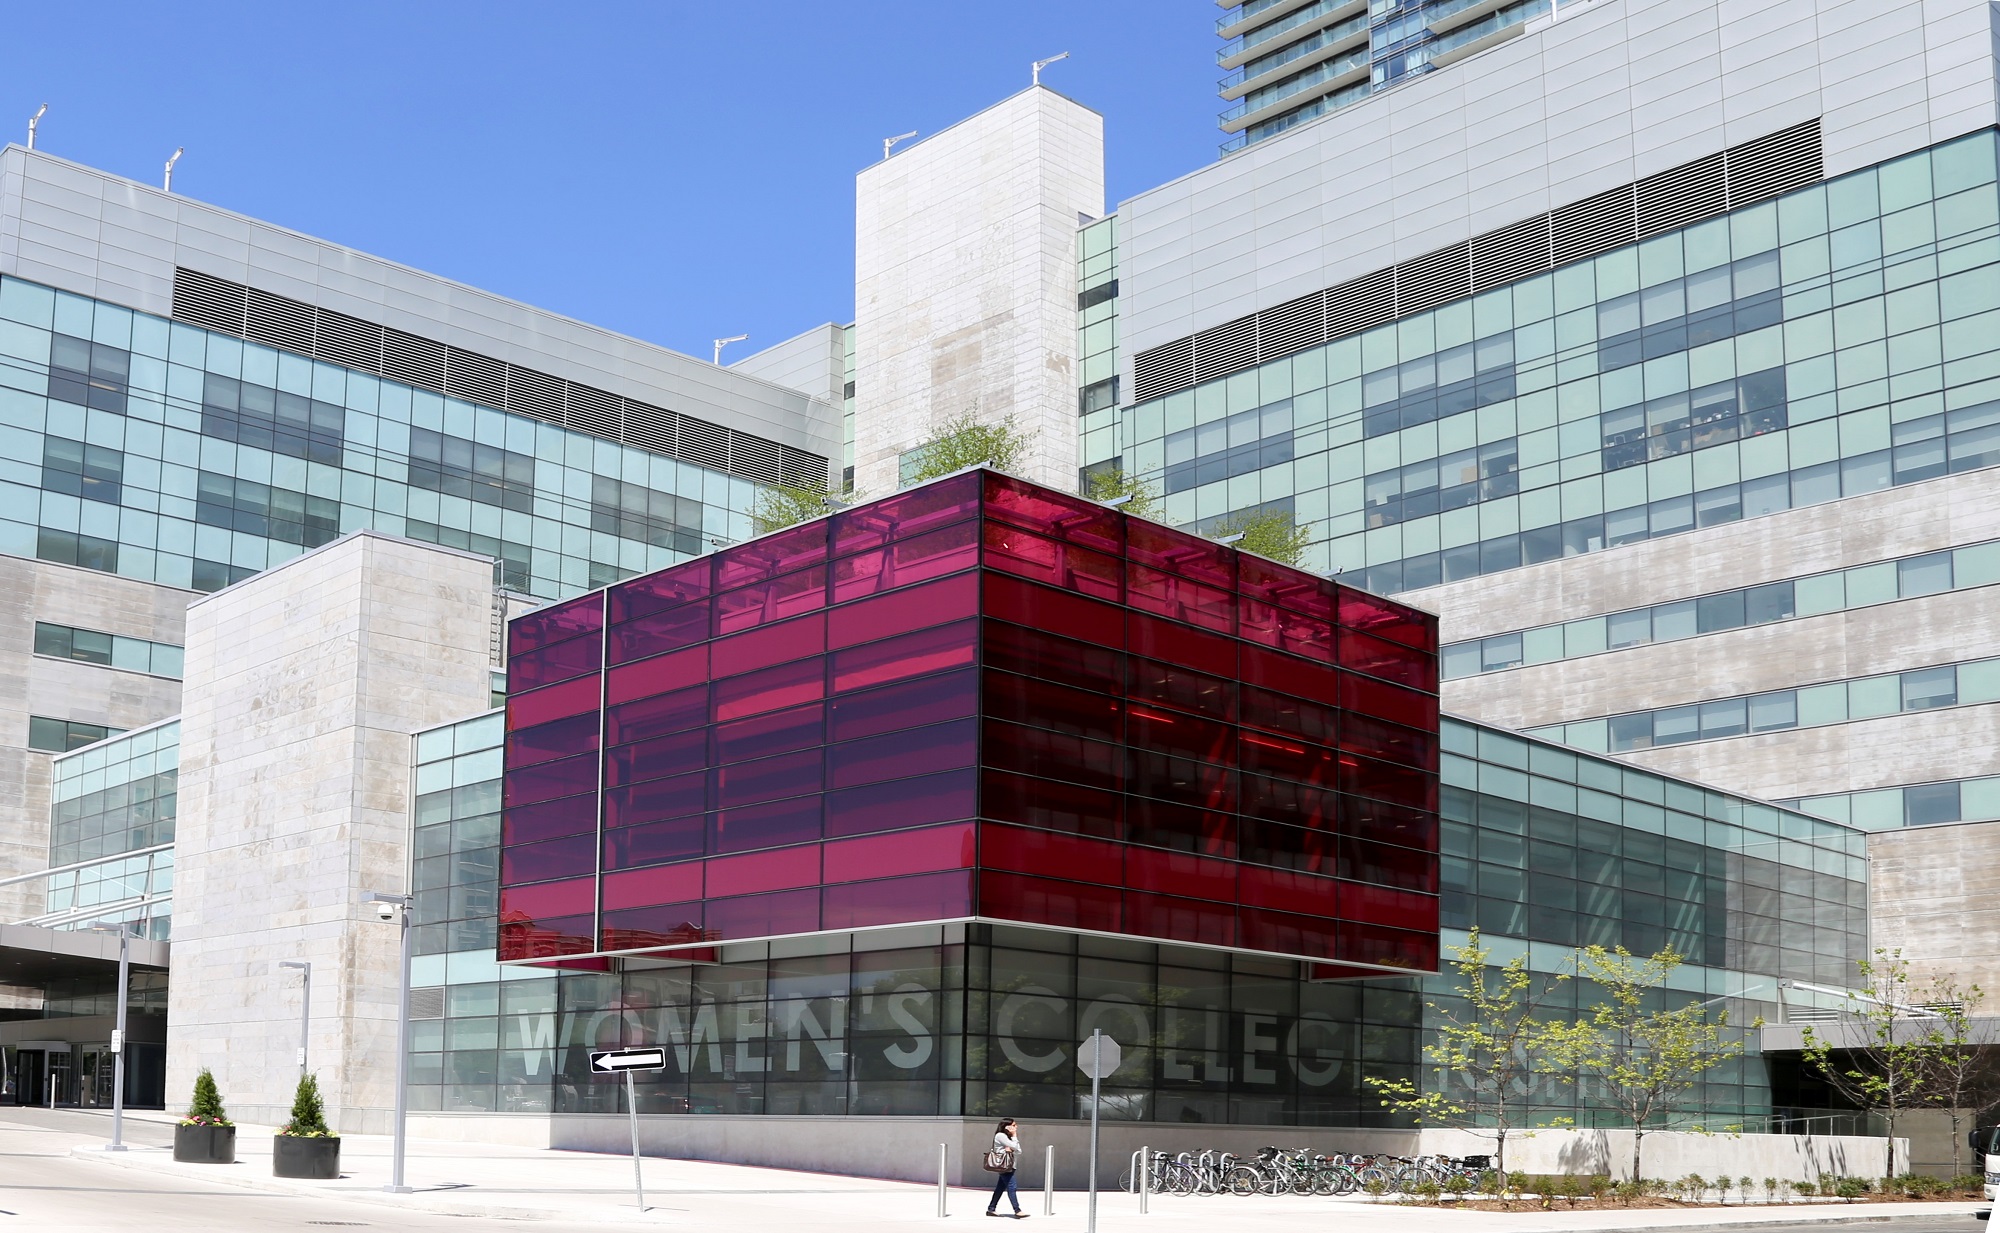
xmin=54 ymin=1119 xmax=1982 ymax=1233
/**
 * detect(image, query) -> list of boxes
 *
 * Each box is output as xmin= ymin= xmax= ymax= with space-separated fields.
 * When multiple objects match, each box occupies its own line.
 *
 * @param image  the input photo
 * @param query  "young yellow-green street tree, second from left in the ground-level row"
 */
xmin=1546 ymin=947 xmax=1744 ymax=1181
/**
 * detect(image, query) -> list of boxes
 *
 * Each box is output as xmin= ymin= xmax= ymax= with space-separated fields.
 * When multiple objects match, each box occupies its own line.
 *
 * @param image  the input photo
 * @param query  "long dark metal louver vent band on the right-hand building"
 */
xmin=1132 ymin=118 xmax=1826 ymax=402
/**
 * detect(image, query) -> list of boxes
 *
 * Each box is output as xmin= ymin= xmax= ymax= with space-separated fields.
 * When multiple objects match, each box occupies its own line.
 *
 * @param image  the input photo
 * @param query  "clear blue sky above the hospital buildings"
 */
xmin=0 ymin=0 xmax=1224 ymax=356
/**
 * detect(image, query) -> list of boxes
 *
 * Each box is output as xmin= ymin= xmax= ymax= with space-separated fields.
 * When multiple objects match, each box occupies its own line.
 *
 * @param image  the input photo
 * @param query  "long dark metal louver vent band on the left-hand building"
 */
xmin=174 ymin=266 xmax=830 ymax=488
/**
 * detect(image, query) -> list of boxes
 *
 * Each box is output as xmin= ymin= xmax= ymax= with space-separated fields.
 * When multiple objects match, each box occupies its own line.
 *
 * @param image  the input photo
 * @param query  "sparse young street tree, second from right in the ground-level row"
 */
xmin=1802 ymin=947 xmax=1940 ymax=1177
